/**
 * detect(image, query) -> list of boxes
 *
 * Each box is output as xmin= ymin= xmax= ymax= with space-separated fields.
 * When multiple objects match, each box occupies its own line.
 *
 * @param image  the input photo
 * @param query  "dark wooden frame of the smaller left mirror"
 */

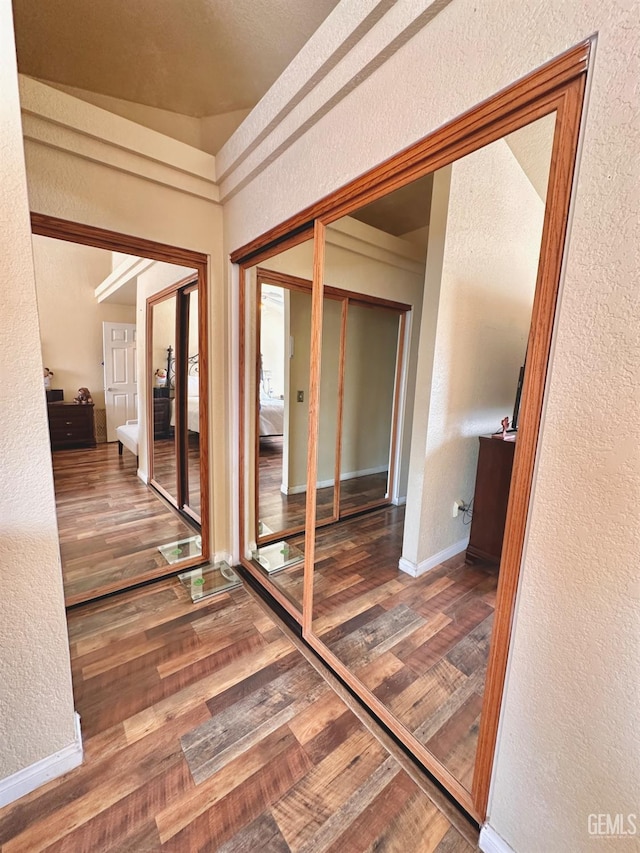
xmin=31 ymin=212 xmax=211 ymax=584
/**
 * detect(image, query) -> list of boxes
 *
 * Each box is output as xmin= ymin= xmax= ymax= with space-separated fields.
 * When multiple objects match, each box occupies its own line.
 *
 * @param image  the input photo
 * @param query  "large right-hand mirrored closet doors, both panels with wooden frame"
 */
xmin=236 ymin=45 xmax=588 ymax=820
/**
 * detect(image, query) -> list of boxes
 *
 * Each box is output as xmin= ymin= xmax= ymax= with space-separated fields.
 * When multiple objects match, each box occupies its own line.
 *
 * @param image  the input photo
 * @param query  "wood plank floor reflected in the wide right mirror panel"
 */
xmin=262 ymin=507 xmax=498 ymax=788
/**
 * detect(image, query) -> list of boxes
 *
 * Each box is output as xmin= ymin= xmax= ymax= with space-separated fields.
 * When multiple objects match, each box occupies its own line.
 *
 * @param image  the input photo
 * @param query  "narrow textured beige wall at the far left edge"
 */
xmin=0 ymin=3 xmax=75 ymax=780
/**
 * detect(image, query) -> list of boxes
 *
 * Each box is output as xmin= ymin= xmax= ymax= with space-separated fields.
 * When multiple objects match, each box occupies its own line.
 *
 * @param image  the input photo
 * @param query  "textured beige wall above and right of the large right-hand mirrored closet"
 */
xmin=223 ymin=0 xmax=640 ymax=853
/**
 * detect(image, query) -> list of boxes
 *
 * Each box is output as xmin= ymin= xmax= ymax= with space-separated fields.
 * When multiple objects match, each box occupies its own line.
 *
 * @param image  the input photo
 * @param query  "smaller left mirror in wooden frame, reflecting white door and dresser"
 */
xmin=32 ymin=220 xmax=210 ymax=606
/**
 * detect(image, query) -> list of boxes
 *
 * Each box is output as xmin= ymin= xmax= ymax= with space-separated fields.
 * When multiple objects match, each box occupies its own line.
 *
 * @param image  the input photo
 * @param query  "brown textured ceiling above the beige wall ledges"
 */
xmin=13 ymin=0 xmax=338 ymax=118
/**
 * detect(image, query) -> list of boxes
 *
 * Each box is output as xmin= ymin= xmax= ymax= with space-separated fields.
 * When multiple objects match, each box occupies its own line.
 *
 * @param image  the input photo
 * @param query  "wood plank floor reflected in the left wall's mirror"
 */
xmin=52 ymin=444 xmax=196 ymax=605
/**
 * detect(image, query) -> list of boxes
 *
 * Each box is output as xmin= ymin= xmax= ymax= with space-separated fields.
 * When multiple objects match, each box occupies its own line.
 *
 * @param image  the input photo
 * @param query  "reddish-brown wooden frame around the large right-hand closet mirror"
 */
xmin=231 ymin=41 xmax=591 ymax=822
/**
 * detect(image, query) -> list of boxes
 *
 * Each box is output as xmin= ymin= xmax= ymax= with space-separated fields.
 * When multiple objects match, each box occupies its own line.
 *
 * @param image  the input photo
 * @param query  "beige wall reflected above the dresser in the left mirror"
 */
xmin=33 ymin=235 xmax=136 ymax=409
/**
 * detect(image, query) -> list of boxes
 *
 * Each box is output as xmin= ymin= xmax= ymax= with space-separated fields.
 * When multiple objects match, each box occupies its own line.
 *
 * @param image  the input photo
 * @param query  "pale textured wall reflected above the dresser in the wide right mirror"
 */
xmin=403 ymin=136 xmax=553 ymax=564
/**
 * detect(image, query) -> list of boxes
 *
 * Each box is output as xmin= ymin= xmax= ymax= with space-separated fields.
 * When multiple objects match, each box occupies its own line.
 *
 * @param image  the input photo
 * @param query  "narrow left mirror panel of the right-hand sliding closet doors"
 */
xmin=244 ymin=241 xmax=313 ymax=609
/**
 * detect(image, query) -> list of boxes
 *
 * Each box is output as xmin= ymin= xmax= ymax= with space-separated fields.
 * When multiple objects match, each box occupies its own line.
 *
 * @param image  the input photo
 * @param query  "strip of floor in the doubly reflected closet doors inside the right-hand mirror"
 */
xmin=259 ymin=436 xmax=387 ymax=531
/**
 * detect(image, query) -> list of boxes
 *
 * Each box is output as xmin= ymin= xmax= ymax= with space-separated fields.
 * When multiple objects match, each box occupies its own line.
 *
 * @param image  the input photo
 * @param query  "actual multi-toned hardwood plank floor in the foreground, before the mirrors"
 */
xmin=0 ymin=579 xmax=477 ymax=853
